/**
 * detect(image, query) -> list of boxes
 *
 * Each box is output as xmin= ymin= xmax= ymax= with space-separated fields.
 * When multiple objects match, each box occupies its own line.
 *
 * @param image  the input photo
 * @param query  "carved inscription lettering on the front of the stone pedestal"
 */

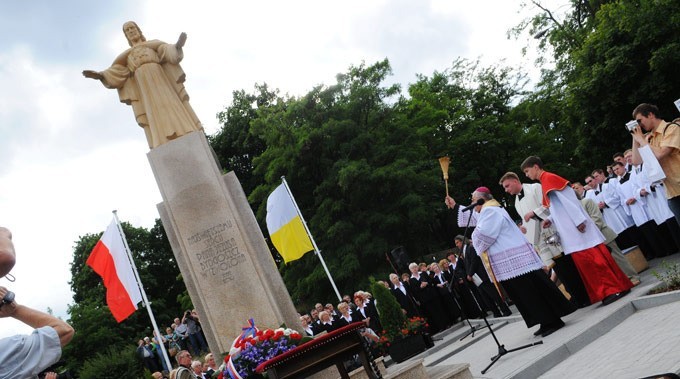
xmin=187 ymin=220 xmax=246 ymax=283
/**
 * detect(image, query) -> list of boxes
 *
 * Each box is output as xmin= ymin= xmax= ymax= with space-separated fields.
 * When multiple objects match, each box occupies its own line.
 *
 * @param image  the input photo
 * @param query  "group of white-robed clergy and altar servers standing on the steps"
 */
xmin=436 ymin=104 xmax=680 ymax=337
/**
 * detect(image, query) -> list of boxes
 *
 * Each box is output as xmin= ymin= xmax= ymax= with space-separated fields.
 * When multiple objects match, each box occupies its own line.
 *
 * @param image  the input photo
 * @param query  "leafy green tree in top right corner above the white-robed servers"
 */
xmin=515 ymin=0 xmax=680 ymax=171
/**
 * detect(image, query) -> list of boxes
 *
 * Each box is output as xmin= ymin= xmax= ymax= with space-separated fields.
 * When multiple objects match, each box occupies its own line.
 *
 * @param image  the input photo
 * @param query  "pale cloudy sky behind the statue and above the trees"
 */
xmin=0 ymin=0 xmax=556 ymax=337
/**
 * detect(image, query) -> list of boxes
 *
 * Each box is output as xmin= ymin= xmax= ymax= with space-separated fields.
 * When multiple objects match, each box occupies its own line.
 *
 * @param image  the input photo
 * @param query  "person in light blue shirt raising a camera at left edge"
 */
xmin=0 ymin=227 xmax=74 ymax=379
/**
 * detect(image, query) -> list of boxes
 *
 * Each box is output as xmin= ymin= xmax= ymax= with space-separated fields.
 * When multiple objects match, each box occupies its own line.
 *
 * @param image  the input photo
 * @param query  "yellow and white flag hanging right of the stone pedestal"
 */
xmin=267 ymin=182 xmax=314 ymax=263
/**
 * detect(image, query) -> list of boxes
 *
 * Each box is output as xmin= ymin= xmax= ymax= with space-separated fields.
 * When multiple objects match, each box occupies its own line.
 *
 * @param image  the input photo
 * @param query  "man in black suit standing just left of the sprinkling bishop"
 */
xmin=455 ymin=235 xmax=512 ymax=317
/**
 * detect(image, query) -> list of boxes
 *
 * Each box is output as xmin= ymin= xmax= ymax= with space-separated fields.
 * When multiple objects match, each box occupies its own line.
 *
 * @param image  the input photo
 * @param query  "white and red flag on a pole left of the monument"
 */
xmin=87 ymin=218 xmax=142 ymax=322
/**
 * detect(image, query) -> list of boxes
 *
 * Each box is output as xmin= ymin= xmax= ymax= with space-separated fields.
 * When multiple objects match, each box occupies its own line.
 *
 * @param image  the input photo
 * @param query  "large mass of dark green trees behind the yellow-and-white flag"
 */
xmin=210 ymin=60 xmax=526 ymax=306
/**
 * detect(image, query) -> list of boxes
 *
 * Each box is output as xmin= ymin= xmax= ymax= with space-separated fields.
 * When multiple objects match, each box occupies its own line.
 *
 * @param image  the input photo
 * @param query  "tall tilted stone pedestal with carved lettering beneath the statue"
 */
xmin=147 ymin=132 xmax=302 ymax=353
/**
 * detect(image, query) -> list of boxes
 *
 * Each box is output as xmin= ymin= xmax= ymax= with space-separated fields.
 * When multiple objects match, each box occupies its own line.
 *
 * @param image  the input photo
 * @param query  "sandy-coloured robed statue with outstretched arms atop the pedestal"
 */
xmin=83 ymin=21 xmax=203 ymax=149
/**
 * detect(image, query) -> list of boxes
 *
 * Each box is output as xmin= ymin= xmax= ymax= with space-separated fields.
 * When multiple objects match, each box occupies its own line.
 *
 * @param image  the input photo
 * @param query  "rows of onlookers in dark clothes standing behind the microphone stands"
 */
xmin=300 ymin=249 xmax=512 ymax=342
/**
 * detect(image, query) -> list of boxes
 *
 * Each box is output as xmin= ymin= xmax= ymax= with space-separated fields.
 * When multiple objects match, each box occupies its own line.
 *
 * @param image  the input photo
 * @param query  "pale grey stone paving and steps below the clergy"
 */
xmin=394 ymin=254 xmax=680 ymax=379
